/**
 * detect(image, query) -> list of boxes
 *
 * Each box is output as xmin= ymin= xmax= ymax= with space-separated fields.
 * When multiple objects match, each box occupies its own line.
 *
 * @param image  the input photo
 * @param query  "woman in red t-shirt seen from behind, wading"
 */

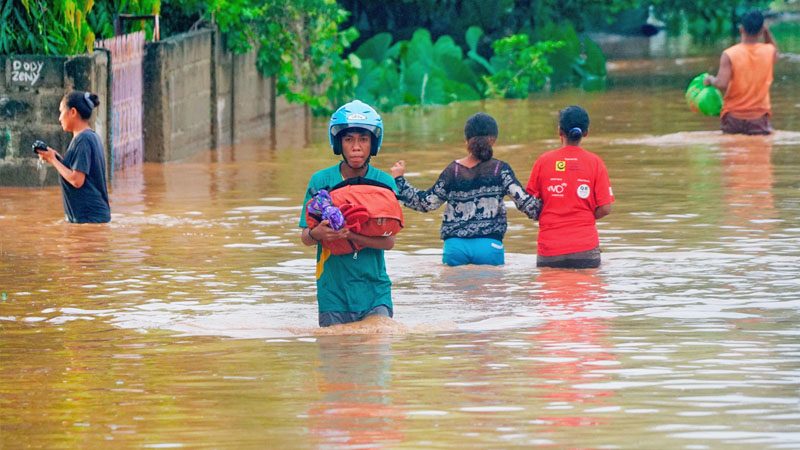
xmin=525 ymin=106 xmax=614 ymax=269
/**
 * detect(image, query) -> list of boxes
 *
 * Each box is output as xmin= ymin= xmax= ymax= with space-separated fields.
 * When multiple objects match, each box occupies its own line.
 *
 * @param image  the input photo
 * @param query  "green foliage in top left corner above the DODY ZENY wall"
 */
xmin=0 ymin=0 xmax=95 ymax=55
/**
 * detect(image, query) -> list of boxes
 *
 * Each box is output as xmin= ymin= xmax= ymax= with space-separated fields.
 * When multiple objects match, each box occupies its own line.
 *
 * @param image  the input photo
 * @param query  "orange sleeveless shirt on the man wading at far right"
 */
xmin=720 ymin=43 xmax=776 ymax=120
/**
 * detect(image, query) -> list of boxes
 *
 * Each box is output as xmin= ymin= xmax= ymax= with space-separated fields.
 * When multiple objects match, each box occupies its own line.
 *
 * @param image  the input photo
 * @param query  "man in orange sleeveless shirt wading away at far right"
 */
xmin=703 ymin=11 xmax=778 ymax=134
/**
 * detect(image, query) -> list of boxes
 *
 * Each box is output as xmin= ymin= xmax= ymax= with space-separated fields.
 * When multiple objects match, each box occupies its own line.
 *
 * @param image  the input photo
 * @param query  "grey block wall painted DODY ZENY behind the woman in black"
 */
xmin=0 ymin=52 xmax=110 ymax=186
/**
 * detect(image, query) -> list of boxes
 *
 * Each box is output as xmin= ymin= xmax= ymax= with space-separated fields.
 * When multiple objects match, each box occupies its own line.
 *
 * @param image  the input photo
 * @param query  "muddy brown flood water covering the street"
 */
xmin=0 ymin=54 xmax=800 ymax=449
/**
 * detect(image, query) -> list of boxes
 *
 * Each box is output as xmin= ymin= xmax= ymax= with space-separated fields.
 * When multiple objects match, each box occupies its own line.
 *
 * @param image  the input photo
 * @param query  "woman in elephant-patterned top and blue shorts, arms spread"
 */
xmin=391 ymin=113 xmax=542 ymax=266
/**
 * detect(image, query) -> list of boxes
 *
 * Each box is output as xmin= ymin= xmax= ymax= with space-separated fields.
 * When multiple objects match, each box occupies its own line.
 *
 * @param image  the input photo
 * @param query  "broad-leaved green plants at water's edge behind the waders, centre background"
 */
xmin=355 ymin=27 xmax=605 ymax=110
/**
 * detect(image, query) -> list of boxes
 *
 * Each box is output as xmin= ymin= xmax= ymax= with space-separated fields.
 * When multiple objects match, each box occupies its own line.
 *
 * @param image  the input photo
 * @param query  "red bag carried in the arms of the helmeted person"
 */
xmin=306 ymin=177 xmax=403 ymax=255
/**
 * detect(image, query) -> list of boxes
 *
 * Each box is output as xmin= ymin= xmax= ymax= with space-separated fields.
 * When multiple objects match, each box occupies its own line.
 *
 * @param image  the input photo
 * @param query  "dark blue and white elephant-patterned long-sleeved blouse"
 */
xmin=395 ymin=158 xmax=542 ymax=241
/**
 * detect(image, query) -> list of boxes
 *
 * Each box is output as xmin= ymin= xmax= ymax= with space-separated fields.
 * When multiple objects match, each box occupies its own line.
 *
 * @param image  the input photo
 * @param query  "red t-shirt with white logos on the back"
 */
xmin=525 ymin=145 xmax=614 ymax=256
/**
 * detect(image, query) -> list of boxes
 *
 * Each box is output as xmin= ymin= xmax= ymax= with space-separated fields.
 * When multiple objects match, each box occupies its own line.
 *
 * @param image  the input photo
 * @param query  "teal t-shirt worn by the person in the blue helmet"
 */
xmin=300 ymin=163 xmax=397 ymax=313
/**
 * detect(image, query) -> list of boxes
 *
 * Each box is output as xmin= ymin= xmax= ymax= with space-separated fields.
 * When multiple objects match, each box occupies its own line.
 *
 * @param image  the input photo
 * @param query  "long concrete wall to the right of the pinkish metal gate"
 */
xmin=144 ymin=30 xmax=309 ymax=162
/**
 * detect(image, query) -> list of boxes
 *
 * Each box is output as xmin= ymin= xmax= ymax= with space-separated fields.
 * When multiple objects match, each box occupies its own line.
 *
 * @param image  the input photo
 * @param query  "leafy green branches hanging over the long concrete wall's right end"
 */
xmin=205 ymin=0 xmax=358 ymax=113
